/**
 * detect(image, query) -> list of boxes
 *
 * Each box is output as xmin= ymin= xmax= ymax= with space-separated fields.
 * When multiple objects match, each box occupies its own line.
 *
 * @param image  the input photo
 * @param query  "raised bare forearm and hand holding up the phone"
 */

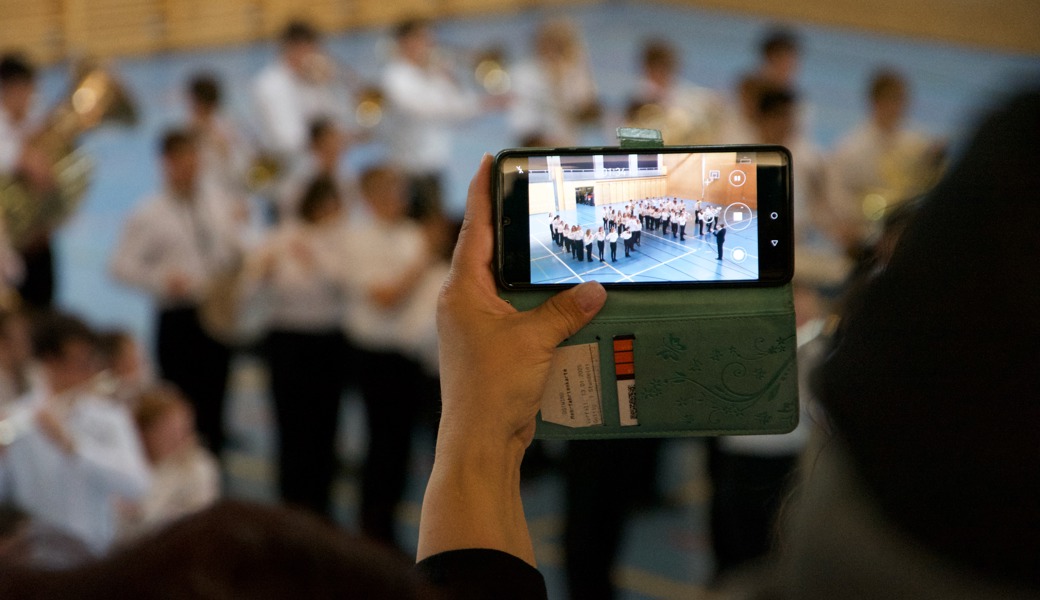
xmin=418 ymin=155 xmax=606 ymax=566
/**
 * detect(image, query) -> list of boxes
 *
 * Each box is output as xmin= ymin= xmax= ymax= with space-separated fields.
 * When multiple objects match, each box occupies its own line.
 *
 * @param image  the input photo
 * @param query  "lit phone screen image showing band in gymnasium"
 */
xmin=527 ymin=152 xmax=758 ymax=284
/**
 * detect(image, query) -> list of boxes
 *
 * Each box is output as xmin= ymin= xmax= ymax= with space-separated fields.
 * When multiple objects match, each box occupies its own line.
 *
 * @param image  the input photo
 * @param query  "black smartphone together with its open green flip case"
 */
xmin=492 ymin=146 xmax=799 ymax=439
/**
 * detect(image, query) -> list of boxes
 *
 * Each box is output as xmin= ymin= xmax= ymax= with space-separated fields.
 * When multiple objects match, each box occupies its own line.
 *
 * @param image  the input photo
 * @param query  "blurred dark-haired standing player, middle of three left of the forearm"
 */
xmin=246 ymin=172 xmax=350 ymax=517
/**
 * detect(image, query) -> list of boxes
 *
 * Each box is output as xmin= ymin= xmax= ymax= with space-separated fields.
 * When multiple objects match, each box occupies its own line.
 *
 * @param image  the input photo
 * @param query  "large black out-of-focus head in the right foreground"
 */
xmin=813 ymin=88 xmax=1040 ymax=590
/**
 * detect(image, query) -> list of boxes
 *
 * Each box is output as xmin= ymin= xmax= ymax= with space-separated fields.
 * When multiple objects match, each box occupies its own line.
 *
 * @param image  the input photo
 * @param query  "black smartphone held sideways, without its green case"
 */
xmin=492 ymin=146 xmax=795 ymax=290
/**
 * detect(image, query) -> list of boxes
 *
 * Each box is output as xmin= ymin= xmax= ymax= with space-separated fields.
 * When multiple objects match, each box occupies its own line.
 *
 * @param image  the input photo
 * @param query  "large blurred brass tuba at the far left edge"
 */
xmin=0 ymin=60 xmax=136 ymax=249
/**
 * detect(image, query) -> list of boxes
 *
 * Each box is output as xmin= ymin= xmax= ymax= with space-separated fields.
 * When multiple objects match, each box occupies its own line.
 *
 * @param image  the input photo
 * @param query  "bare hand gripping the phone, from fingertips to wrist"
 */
xmin=437 ymin=156 xmax=606 ymax=449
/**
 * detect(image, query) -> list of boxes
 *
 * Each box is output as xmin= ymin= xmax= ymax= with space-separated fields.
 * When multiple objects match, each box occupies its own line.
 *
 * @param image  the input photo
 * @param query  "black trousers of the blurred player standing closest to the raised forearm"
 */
xmin=355 ymin=348 xmax=433 ymax=545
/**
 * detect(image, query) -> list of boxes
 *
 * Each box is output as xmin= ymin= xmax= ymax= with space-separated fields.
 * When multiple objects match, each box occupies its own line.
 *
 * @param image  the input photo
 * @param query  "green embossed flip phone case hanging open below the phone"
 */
xmin=500 ymin=129 xmax=799 ymax=439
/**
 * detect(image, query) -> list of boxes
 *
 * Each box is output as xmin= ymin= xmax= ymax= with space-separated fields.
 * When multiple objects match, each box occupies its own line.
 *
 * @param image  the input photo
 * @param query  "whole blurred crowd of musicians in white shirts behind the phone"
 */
xmin=0 ymin=11 xmax=956 ymax=598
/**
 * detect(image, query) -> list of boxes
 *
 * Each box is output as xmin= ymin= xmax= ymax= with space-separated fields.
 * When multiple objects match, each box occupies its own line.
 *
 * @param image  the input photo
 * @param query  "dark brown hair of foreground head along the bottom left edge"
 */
xmin=0 ymin=501 xmax=438 ymax=600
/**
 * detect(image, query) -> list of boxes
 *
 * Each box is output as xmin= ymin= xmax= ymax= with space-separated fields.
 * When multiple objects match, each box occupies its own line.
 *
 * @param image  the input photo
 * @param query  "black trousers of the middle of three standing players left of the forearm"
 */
xmin=264 ymin=328 xmax=350 ymax=517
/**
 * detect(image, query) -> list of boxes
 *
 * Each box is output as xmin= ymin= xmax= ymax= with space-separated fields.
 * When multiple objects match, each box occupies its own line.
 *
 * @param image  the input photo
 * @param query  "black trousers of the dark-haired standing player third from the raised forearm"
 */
xmin=156 ymin=307 xmax=231 ymax=456
